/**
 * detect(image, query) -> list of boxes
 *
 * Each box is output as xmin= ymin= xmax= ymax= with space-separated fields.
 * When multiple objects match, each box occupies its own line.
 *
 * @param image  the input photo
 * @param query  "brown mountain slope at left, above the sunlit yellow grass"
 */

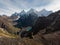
xmin=0 ymin=17 xmax=19 ymax=33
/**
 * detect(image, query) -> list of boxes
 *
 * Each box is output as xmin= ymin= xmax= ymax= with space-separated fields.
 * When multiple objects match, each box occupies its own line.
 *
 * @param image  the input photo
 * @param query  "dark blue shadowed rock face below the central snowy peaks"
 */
xmin=15 ymin=13 xmax=38 ymax=27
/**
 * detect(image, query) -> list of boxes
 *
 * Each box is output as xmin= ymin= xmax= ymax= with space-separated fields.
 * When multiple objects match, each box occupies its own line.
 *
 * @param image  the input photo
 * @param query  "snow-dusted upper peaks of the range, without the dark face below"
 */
xmin=11 ymin=8 xmax=53 ymax=19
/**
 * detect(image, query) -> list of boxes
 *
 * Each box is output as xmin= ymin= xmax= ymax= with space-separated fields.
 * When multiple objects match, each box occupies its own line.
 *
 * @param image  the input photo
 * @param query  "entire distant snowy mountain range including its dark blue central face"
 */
xmin=11 ymin=8 xmax=52 ymax=26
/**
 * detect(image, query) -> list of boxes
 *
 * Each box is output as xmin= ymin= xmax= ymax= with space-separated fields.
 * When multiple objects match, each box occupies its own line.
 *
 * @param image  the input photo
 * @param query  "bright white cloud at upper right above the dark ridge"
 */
xmin=37 ymin=0 xmax=60 ymax=12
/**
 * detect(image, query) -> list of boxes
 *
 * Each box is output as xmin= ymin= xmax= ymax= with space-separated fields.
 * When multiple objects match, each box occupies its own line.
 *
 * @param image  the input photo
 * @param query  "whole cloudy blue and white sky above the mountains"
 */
xmin=0 ymin=0 xmax=60 ymax=16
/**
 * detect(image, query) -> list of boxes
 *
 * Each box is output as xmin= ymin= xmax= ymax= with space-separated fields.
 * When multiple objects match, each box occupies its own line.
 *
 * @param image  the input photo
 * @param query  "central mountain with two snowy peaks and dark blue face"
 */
xmin=15 ymin=9 xmax=38 ymax=27
